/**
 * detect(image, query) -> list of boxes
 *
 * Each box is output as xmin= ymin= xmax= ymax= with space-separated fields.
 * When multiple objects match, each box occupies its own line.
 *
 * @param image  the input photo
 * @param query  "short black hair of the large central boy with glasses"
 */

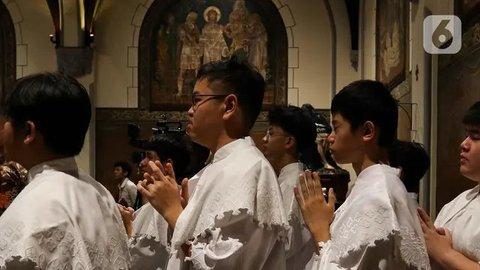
xmin=197 ymin=57 xmax=265 ymax=130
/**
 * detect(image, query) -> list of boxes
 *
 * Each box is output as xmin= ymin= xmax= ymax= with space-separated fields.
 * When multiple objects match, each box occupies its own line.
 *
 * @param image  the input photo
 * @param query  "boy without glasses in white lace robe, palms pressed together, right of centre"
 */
xmin=295 ymin=81 xmax=430 ymax=270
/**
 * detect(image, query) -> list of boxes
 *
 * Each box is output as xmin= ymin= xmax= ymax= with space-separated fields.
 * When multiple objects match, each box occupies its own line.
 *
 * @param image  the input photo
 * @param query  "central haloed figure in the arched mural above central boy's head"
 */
xmin=200 ymin=6 xmax=228 ymax=64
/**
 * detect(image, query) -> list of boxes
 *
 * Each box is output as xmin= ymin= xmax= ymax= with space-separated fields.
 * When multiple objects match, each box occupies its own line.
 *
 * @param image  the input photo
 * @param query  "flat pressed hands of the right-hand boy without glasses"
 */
xmin=294 ymin=170 xmax=336 ymax=252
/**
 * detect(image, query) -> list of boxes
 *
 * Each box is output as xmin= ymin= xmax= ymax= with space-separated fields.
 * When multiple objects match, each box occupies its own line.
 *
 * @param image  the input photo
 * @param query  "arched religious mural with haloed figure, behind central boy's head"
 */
xmin=139 ymin=0 xmax=286 ymax=110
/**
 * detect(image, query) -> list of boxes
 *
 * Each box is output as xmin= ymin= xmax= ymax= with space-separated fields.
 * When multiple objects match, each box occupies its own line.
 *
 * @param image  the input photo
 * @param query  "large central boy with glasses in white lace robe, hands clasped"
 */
xmin=138 ymin=59 xmax=287 ymax=269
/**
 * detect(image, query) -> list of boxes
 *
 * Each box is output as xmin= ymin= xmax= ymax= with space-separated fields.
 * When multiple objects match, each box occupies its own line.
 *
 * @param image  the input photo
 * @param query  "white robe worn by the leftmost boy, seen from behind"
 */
xmin=0 ymin=157 xmax=130 ymax=270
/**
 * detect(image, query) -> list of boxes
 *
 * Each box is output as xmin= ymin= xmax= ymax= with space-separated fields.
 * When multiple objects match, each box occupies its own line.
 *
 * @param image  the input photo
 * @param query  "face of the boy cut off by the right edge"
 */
xmin=460 ymin=124 xmax=480 ymax=182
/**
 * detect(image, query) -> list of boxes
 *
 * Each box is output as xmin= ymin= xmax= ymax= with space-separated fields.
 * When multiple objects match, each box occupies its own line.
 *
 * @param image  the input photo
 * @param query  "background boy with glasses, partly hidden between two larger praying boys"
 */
xmin=262 ymin=106 xmax=321 ymax=270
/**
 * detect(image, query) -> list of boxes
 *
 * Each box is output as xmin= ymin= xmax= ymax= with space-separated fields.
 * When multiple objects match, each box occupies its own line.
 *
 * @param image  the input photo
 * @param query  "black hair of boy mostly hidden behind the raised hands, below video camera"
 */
xmin=144 ymin=132 xmax=191 ymax=181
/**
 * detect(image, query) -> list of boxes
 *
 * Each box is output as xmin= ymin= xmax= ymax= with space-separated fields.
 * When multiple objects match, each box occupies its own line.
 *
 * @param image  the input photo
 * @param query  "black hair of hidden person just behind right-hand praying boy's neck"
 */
xmin=388 ymin=140 xmax=430 ymax=193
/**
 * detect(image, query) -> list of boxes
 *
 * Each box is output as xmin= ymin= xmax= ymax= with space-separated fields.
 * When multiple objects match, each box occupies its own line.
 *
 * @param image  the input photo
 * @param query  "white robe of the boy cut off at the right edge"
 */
xmin=432 ymin=185 xmax=480 ymax=269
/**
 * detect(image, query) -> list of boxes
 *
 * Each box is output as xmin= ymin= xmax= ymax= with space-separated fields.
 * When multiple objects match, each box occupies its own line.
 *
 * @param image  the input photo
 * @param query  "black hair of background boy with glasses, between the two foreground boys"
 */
xmin=267 ymin=105 xmax=320 ymax=169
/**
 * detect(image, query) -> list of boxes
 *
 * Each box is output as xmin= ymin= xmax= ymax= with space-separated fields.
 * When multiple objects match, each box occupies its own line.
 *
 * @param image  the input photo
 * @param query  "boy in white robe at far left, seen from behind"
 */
xmin=0 ymin=73 xmax=130 ymax=270
